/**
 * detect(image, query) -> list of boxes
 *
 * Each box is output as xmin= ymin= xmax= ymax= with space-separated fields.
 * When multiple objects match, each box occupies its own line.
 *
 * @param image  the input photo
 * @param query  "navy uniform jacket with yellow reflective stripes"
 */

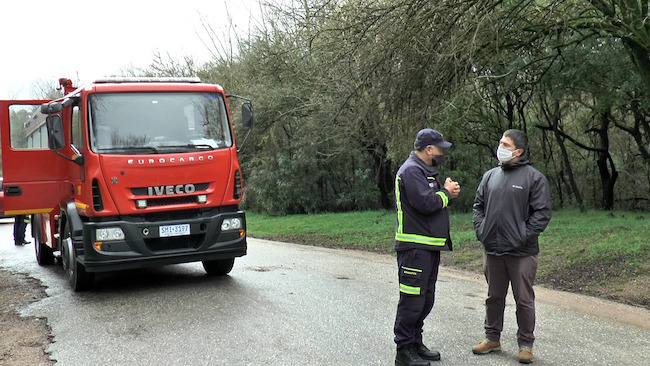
xmin=395 ymin=152 xmax=452 ymax=251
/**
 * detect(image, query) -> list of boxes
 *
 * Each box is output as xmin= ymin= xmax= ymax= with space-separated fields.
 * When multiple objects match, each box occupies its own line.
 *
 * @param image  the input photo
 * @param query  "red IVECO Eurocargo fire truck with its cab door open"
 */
xmin=0 ymin=78 xmax=253 ymax=291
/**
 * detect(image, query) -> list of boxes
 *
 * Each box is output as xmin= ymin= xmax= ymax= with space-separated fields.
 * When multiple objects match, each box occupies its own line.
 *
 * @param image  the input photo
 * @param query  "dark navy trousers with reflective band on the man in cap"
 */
xmin=394 ymin=249 xmax=440 ymax=349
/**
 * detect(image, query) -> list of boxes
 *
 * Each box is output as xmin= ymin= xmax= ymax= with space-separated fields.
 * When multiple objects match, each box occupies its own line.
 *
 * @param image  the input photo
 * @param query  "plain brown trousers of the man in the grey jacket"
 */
xmin=483 ymin=253 xmax=537 ymax=347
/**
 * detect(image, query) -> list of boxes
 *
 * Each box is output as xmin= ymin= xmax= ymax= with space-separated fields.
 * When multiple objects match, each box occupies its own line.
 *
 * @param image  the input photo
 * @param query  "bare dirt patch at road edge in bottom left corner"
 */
xmin=0 ymin=271 xmax=55 ymax=366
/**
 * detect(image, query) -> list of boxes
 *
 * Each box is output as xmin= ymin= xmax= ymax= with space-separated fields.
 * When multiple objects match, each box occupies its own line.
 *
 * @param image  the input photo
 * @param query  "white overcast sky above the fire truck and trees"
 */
xmin=0 ymin=0 xmax=260 ymax=99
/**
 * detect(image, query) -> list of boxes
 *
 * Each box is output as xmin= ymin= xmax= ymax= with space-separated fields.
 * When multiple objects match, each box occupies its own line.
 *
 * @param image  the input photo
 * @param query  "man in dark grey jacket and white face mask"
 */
xmin=472 ymin=130 xmax=551 ymax=363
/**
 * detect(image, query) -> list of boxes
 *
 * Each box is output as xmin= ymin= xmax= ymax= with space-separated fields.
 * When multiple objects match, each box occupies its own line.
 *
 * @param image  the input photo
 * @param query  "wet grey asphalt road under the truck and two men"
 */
xmin=0 ymin=221 xmax=650 ymax=366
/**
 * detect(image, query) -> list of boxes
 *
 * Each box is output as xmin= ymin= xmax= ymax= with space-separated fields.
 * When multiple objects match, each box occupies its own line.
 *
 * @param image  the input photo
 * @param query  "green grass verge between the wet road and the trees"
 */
xmin=247 ymin=210 xmax=650 ymax=298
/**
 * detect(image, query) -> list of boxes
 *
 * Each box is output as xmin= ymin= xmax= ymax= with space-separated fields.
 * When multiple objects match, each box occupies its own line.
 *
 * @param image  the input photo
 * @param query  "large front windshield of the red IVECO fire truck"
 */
xmin=88 ymin=93 xmax=233 ymax=154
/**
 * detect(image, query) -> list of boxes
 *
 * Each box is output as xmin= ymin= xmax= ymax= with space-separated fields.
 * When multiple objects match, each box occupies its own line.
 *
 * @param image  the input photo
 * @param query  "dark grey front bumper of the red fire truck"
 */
xmin=77 ymin=210 xmax=247 ymax=272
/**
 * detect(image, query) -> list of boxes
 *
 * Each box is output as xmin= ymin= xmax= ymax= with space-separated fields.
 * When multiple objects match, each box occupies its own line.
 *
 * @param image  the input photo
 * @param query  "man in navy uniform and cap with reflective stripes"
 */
xmin=394 ymin=128 xmax=460 ymax=366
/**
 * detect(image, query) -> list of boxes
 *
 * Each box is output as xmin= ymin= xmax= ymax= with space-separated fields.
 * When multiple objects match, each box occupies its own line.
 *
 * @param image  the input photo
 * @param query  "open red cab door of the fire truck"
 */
xmin=0 ymin=100 xmax=73 ymax=215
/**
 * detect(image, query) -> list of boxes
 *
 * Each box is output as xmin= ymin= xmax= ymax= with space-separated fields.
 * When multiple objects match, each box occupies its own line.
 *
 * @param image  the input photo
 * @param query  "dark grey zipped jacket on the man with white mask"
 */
xmin=473 ymin=155 xmax=551 ymax=257
